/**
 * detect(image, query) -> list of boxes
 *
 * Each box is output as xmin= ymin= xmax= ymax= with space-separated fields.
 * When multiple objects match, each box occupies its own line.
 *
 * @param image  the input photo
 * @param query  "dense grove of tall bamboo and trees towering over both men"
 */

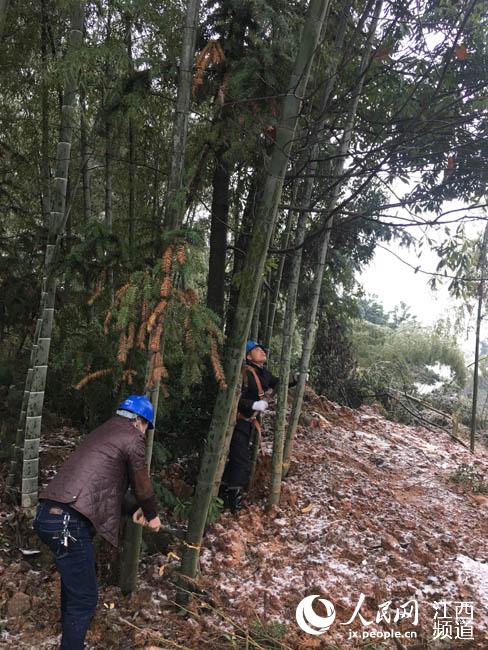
xmin=0 ymin=0 xmax=488 ymax=591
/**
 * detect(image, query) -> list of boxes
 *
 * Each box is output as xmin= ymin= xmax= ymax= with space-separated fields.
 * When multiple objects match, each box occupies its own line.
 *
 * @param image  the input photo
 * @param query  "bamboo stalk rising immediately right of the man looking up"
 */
xmin=269 ymin=1 xmax=349 ymax=507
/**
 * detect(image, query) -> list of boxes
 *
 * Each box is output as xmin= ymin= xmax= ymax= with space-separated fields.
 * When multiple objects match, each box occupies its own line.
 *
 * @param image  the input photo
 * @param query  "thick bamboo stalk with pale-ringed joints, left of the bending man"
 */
xmin=22 ymin=0 xmax=85 ymax=511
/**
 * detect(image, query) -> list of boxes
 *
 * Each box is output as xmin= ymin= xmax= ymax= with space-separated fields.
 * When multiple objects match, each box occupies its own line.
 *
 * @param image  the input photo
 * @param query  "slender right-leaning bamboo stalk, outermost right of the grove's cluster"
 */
xmin=282 ymin=0 xmax=383 ymax=475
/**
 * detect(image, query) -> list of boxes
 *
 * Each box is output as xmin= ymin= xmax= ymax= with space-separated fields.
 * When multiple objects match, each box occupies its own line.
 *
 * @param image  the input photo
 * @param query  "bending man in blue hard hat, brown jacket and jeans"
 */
xmin=34 ymin=395 xmax=161 ymax=650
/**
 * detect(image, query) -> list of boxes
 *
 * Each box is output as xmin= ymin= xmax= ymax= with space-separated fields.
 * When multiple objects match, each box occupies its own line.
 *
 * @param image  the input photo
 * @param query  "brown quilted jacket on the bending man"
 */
xmin=39 ymin=415 xmax=157 ymax=546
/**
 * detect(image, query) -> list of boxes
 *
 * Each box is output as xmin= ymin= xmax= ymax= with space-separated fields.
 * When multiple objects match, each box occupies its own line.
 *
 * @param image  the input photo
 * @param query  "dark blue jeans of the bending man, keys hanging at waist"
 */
xmin=34 ymin=501 xmax=98 ymax=650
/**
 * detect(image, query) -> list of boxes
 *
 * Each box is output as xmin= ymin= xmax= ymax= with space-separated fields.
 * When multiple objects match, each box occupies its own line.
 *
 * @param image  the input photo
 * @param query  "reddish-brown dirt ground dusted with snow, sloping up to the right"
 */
xmin=0 ymin=394 xmax=488 ymax=650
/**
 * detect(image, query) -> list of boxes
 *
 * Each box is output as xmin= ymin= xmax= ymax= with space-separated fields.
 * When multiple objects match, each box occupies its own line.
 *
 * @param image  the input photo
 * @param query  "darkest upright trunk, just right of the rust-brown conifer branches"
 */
xmin=207 ymin=147 xmax=230 ymax=319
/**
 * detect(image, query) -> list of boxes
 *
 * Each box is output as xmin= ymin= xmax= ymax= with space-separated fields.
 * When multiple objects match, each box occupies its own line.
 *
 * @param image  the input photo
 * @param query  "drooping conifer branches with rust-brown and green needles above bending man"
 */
xmin=76 ymin=233 xmax=225 ymax=396
